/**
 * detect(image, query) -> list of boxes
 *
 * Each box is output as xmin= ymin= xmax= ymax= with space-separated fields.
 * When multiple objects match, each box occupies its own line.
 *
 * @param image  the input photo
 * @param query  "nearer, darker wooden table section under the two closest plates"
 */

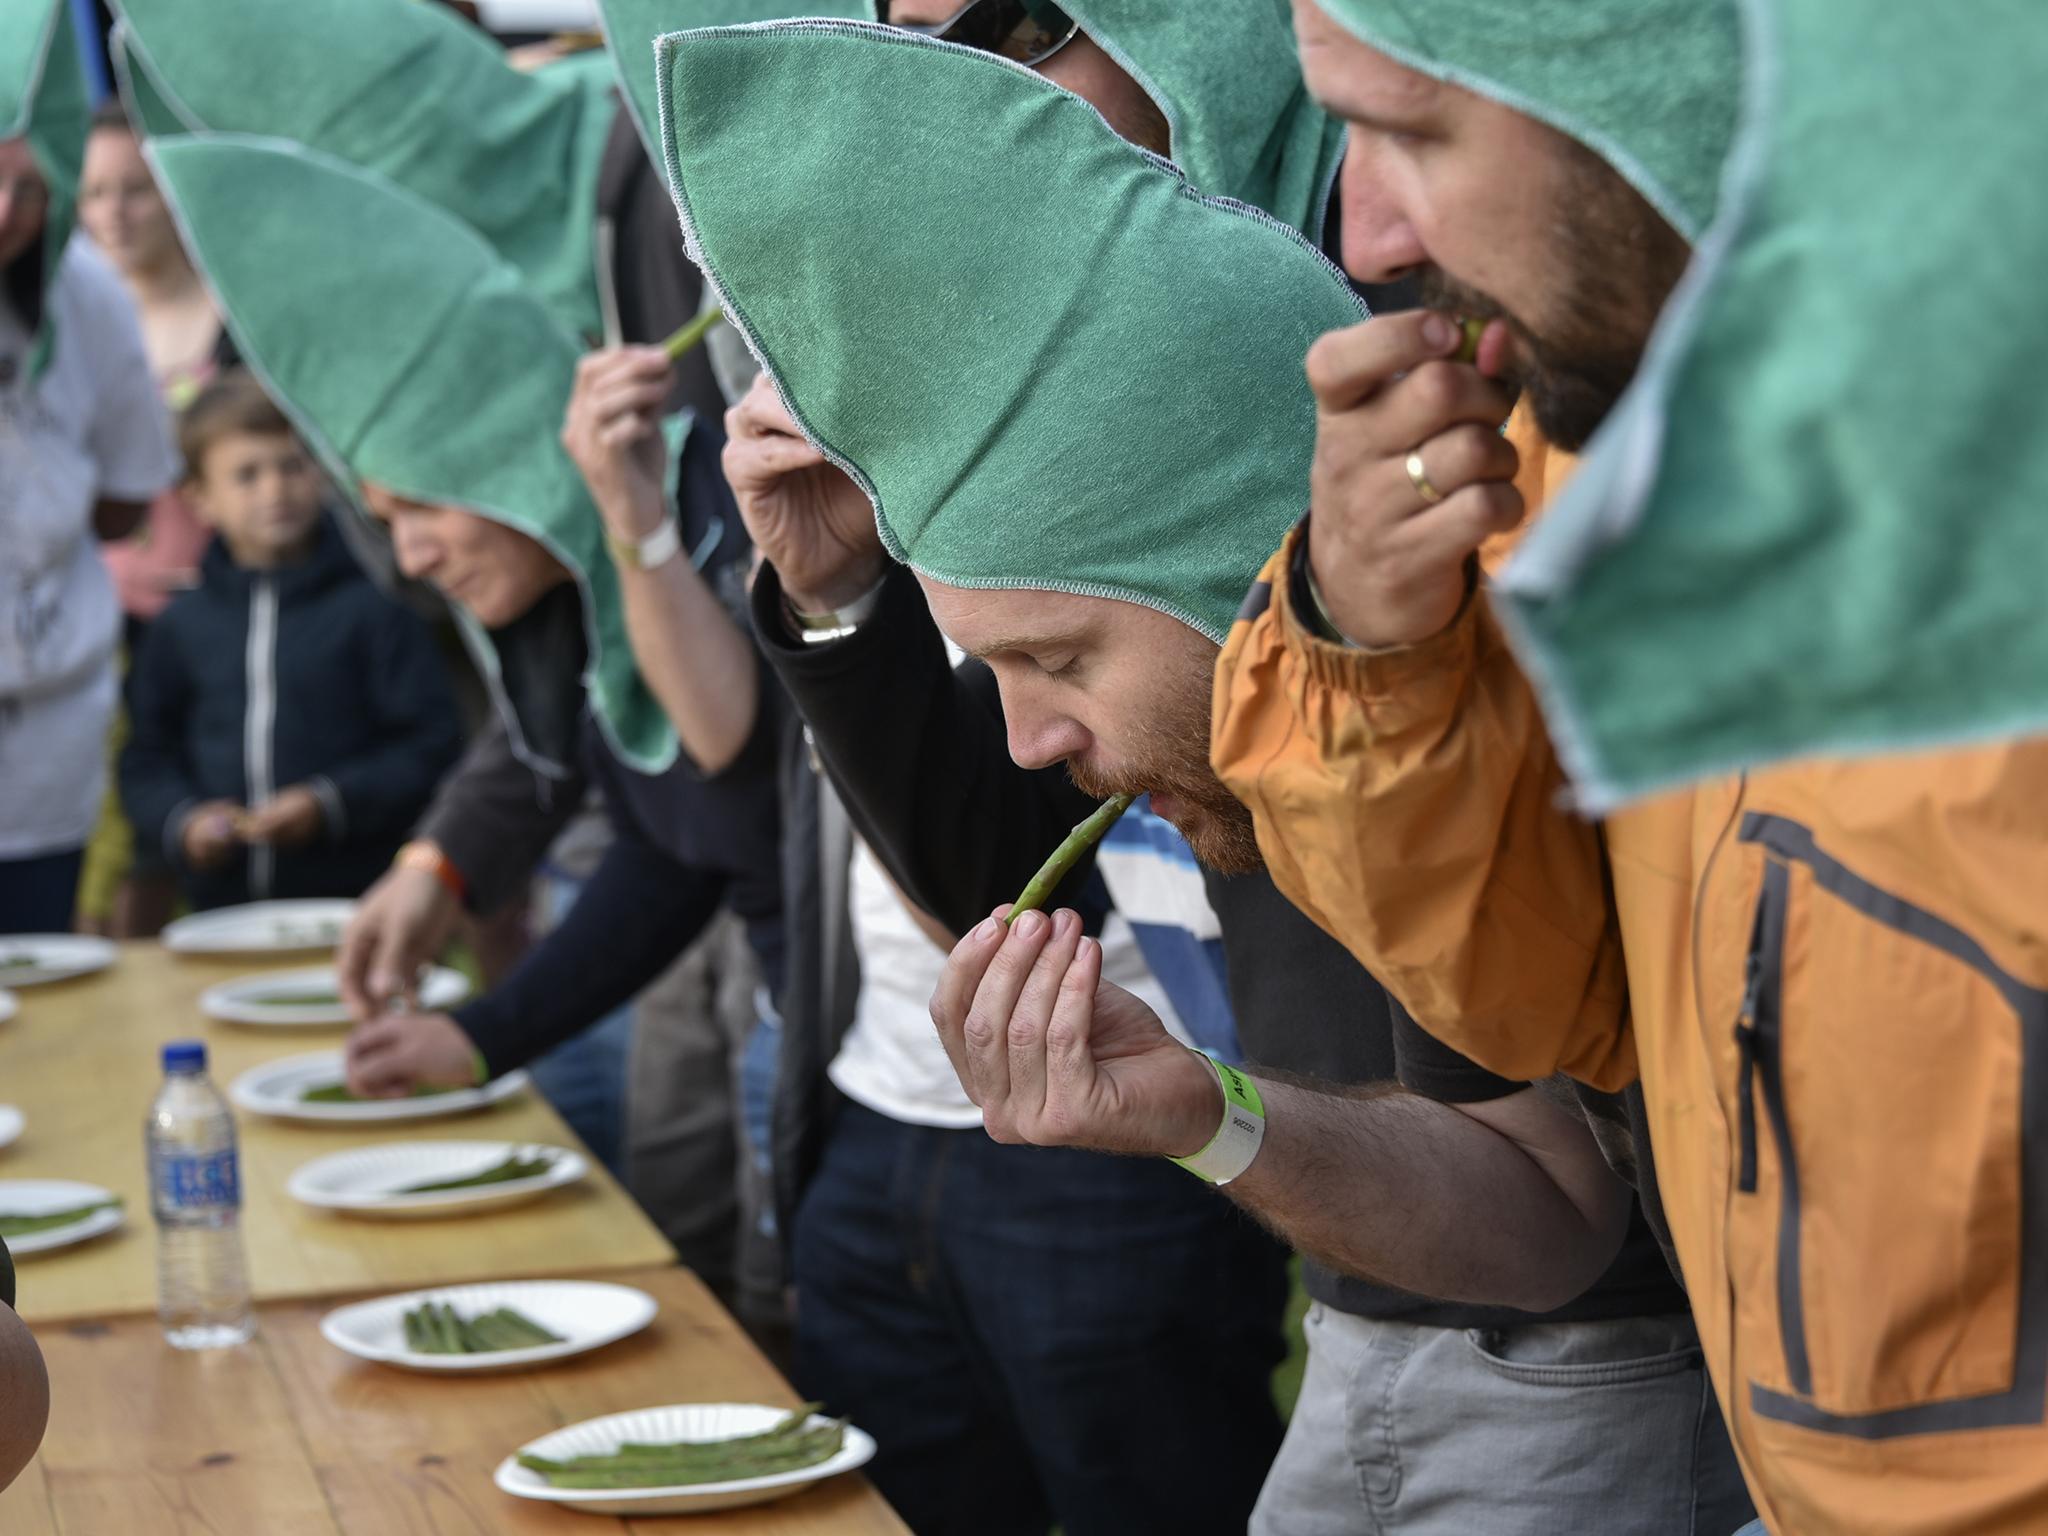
xmin=0 ymin=1268 xmax=907 ymax=1536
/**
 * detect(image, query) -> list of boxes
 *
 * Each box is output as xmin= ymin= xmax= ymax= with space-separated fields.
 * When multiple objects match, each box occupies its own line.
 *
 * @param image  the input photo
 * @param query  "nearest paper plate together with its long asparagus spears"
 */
xmin=494 ymin=1403 xmax=874 ymax=1518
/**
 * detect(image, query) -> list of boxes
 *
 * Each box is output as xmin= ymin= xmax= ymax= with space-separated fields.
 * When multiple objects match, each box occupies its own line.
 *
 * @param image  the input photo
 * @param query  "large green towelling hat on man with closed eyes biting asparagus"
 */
xmin=659 ymin=20 xmax=1364 ymax=641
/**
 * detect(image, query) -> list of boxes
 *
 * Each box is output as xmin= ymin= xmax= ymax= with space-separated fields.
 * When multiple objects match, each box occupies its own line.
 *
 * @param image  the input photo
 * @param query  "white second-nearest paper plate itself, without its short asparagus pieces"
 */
xmin=319 ymin=1280 xmax=657 ymax=1376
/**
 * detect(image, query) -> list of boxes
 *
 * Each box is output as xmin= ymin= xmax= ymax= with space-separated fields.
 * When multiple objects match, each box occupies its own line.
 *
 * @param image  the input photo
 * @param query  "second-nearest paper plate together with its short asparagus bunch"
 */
xmin=319 ymin=1280 xmax=655 ymax=1374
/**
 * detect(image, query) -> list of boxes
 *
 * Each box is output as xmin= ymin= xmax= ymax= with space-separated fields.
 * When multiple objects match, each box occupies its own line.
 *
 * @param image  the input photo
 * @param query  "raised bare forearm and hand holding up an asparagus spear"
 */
xmin=561 ymin=346 xmax=758 ymax=774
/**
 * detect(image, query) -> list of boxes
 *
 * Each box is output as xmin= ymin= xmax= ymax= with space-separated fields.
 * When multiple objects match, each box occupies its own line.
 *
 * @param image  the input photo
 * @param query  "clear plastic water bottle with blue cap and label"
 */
xmin=143 ymin=1040 xmax=256 ymax=1350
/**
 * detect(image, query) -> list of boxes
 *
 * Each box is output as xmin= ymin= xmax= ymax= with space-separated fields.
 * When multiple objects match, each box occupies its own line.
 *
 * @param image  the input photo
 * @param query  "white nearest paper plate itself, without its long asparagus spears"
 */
xmin=503 ymin=1403 xmax=874 ymax=1520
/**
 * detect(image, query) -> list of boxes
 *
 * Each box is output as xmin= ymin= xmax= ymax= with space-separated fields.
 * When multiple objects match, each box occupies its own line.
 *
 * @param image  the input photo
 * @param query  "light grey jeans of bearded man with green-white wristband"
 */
xmin=1251 ymin=1305 xmax=1755 ymax=1536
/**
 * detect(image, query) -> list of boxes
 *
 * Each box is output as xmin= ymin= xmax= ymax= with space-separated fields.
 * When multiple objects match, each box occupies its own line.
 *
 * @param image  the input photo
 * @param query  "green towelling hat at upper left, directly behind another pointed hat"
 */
xmin=113 ymin=0 xmax=616 ymax=334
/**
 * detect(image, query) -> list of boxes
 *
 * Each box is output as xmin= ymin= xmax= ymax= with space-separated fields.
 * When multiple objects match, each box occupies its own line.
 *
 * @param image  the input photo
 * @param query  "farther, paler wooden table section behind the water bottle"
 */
xmin=0 ymin=944 xmax=674 ymax=1323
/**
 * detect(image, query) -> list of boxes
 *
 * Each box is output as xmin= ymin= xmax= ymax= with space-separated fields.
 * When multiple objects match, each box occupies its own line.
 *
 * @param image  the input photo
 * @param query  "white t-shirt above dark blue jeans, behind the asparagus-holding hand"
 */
xmin=827 ymin=842 xmax=1188 ymax=1130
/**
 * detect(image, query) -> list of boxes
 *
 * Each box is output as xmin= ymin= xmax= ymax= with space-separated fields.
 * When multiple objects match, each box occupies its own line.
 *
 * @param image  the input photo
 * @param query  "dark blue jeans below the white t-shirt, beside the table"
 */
xmin=793 ymin=1106 xmax=1288 ymax=1536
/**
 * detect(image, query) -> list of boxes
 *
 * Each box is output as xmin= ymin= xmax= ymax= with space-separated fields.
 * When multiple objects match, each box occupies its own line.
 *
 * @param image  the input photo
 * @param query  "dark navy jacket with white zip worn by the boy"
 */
xmin=121 ymin=518 xmax=463 ymax=907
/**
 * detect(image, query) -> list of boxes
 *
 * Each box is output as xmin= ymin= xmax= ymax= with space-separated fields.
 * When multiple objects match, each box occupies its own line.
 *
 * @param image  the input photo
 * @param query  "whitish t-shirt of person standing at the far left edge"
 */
xmin=0 ymin=246 xmax=178 ymax=858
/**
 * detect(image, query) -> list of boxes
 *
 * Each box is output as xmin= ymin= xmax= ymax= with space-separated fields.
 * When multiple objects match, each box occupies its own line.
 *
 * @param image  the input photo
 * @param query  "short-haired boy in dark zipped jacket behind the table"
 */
xmin=121 ymin=371 xmax=463 ymax=909
